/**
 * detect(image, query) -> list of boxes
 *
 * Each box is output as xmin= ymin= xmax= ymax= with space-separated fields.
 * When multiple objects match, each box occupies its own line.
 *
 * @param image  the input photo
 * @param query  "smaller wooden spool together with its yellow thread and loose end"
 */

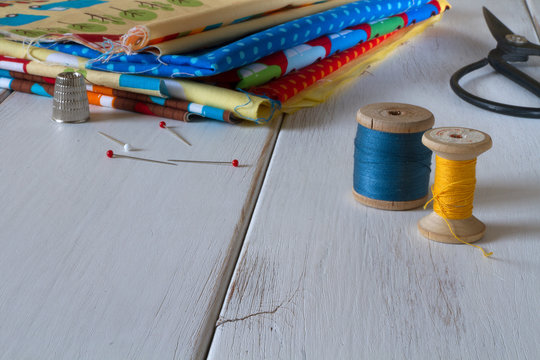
xmin=418 ymin=128 xmax=492 ymax=252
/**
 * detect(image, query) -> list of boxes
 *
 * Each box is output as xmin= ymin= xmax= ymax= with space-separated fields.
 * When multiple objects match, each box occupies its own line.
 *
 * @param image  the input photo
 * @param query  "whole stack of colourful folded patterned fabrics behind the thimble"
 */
xmin=0 ymin=0 xmax=449 ymax=123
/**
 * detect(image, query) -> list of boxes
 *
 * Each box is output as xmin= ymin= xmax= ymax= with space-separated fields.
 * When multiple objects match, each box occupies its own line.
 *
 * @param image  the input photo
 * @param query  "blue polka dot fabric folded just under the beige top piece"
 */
xmin=46 ymin=0 xmax=429 ymax=77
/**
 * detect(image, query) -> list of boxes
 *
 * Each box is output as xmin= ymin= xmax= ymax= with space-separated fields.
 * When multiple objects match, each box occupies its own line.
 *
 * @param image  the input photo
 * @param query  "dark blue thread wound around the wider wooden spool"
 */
xmin=353 ymin=125 xmax=432 ymax=201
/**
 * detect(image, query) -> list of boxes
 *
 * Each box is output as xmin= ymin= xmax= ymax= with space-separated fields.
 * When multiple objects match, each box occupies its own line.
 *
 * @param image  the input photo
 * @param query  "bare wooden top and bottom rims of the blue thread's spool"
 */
xmin=353 ymin=103 xmax=435 ymax=210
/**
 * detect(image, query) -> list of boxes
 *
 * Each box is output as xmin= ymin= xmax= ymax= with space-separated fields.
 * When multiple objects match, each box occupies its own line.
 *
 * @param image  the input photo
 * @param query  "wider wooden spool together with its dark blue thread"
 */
xmin=353 ymin=103 xmax=435 ymax=210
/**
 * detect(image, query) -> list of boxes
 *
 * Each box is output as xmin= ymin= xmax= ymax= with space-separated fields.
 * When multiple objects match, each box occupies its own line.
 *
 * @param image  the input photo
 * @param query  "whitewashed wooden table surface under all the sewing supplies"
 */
xmin=0 ymin=0 xmax=540 ymax=359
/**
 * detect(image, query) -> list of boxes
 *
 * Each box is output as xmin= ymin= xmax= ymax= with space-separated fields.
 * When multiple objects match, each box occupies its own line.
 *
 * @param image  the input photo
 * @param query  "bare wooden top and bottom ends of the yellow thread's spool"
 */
xmin=418 ymin=128 xmax=492 ymax=244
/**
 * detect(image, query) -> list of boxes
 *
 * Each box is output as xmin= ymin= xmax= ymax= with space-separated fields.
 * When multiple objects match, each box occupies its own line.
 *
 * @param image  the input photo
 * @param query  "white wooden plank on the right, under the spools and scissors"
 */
xmin=209 ymin=0 xmax=540 ymax=359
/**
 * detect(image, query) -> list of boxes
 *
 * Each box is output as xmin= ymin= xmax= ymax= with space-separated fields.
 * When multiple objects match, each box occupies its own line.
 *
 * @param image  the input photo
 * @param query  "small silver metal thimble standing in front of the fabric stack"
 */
xmin=52 ymin=72 xmax=90 ymax=123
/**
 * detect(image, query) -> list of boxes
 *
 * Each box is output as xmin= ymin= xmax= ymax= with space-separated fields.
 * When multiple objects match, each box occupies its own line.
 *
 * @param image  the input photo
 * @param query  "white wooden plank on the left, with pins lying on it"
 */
xmin=0 ymin=93 xmax=280 ymax=359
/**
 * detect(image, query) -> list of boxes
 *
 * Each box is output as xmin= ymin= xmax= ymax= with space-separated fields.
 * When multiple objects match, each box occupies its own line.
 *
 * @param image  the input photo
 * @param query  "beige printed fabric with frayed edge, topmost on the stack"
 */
xmin=0 ymin=0 xmax=356 ymax=53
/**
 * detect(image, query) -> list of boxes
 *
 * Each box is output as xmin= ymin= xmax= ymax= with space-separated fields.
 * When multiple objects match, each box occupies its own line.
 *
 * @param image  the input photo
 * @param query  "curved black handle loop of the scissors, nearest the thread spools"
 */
xmin=450 ymin=58 xmax=540 ymax=118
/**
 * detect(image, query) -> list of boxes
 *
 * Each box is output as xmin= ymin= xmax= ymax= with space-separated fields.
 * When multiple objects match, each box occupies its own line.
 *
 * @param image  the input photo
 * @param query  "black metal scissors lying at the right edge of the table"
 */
xmin=450 ymin=7 xmax=540 ymax=118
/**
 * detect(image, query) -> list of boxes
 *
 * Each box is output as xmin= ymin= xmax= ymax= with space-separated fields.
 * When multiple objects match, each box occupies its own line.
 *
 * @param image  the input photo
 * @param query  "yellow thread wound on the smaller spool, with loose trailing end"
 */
xmin=424 ymin=156 xmax=493 ymax=257
